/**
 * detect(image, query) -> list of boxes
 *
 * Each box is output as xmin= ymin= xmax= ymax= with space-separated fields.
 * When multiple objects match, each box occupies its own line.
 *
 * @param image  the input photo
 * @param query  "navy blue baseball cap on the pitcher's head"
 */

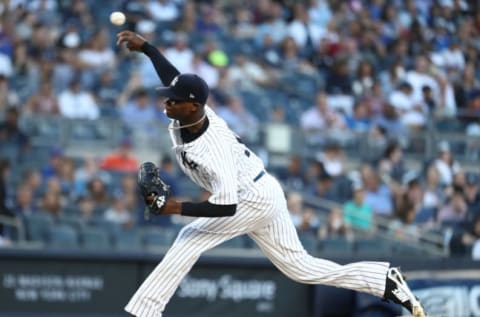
xmin=157 ymin=74 xmax=209 ymax=105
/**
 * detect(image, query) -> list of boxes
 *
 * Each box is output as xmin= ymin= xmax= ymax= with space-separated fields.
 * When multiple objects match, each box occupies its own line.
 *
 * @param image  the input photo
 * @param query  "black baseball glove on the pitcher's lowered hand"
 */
xmin=138 ymin=162 xmax=170 ymax=219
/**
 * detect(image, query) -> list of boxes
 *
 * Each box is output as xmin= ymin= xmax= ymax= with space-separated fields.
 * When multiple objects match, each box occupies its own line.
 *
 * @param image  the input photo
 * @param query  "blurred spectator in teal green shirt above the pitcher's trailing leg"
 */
xmin=343 ymin=184 xmax=373 ymax=231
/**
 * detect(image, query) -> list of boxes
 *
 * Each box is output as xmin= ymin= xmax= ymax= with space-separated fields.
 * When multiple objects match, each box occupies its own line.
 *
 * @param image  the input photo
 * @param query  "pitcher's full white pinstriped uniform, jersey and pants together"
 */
xmin=125 ymin=106 xmax=389 ymax=317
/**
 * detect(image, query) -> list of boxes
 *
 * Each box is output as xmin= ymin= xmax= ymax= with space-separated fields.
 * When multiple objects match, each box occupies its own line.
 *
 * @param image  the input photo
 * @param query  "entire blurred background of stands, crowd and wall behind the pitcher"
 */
xmin=0 ymin=0 xmax=480 ymax=317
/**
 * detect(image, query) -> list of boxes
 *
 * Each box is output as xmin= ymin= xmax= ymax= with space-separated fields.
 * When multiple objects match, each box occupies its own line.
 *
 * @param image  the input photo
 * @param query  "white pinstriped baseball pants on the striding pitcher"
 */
xmin=125 ymin=174 xmax=390 ymax=317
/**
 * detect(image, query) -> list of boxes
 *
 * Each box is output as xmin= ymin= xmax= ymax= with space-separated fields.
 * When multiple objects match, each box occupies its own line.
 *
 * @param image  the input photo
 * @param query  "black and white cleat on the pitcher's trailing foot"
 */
xmin=383 ymin=267 xmax=425 ymax=317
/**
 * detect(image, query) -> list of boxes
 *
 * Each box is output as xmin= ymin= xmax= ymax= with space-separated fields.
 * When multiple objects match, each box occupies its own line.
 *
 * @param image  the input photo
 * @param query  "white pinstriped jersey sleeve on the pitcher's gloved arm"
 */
xmin=208 ymin=146 xmax=238 ymax=205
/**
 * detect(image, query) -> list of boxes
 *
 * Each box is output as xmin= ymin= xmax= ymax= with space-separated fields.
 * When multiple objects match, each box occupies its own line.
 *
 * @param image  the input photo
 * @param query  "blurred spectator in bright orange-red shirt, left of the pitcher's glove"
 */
xmin=100 ymin=139 xmax=138 ymax=173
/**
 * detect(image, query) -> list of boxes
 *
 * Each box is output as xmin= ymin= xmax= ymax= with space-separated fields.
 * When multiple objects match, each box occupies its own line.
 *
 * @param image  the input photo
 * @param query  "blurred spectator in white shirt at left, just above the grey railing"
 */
xmin=58 ymin=78 xmax=100 ymax=120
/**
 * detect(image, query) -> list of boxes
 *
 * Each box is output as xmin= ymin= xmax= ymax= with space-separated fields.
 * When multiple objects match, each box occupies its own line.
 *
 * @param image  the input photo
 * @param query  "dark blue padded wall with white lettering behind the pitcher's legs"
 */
xmin=0 ymin=250 xmax=480 ymax=317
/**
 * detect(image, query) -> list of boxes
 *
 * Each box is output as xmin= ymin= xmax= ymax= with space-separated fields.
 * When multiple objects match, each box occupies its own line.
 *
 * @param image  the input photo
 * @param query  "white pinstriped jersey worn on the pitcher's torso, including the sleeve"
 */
xmin=169 ymin=106 xmax=264 ymax=205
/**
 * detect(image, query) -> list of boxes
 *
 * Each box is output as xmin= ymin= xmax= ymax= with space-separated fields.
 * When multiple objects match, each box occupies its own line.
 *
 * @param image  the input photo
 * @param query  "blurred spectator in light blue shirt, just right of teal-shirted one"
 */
xmin=361 ymin=166 xmax=393 ymax=216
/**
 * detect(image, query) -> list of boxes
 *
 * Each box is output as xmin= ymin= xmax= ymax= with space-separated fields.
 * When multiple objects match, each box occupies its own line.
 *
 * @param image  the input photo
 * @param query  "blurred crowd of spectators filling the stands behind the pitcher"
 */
xmin=0 ymin=0 xmax=480 ymax=258
